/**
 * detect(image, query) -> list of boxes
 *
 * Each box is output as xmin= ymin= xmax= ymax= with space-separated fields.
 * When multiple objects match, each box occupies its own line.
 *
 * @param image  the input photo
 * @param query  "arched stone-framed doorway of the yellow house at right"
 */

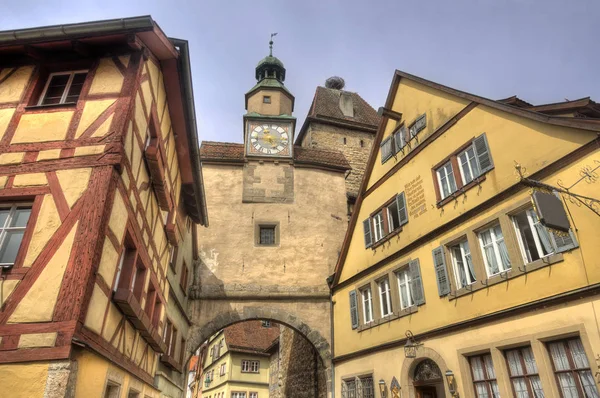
xmin=400 ymin=346 xmax=451 ymax=398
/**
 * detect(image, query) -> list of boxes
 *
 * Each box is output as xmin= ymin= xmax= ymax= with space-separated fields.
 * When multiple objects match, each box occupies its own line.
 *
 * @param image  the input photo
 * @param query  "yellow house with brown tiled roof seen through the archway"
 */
xmin=199 ymin=321 xmax=279 ymax=398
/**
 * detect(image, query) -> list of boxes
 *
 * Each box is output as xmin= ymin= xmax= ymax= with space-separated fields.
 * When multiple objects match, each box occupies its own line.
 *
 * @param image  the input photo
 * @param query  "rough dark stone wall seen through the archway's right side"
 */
xmin=270 ymin=326 xmax=327 ymax=398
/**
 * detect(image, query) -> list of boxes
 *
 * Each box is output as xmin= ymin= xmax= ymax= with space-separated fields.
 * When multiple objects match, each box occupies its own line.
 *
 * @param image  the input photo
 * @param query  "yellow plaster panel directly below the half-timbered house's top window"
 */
xmin=11 ymin=111 xmax=73 ymax=144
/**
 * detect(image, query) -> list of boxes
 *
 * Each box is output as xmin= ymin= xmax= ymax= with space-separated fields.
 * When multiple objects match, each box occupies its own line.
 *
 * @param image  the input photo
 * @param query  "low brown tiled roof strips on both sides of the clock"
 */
xmin=200 ymin=141 xmax=351 ymax=171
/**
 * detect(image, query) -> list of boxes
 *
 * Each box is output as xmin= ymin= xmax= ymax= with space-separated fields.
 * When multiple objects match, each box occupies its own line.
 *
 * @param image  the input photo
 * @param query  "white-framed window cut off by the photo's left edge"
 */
xmin=0 ymin=203 xmax=31 ymax=267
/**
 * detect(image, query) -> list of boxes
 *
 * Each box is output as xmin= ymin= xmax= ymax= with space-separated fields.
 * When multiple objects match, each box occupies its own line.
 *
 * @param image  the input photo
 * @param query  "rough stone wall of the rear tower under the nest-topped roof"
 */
xmin=302 ymin=122 xmax=375 ymax=197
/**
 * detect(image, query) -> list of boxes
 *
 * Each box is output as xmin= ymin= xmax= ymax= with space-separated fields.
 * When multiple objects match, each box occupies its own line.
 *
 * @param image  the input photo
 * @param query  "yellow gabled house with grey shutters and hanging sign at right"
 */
xmin=332 ymin=71 xmax=600 ymax=398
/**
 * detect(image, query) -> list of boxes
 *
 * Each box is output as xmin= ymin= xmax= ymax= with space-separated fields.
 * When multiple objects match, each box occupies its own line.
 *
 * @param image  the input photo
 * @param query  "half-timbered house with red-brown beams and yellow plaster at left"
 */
xmin=0 ymin=17 xmax=207 ymax=398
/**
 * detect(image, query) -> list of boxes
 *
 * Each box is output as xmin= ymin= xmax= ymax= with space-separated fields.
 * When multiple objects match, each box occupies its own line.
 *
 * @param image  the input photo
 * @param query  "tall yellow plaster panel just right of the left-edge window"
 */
xmin=23 ymin=194 xmax=61 ymax=267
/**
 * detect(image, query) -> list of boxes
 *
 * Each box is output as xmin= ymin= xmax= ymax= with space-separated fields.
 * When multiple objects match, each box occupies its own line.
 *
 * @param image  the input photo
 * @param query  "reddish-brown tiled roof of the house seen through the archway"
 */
xmin=223 ymin=320 xmax=279 ymax=353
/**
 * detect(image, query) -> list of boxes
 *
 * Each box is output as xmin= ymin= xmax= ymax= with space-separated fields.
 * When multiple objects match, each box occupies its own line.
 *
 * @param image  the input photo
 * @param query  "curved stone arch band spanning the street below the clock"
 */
xmin=186 ymin=306 xmax=332 ymax=397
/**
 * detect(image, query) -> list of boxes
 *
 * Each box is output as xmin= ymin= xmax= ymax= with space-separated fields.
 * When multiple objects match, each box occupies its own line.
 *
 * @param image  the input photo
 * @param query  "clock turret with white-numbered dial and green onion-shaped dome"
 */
xmin=244 ymin=37 xmax=296 ymax=158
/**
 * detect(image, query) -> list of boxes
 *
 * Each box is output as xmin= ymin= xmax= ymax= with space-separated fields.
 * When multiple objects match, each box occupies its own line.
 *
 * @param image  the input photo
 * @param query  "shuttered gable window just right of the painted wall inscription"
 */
xmin=435 ymin=134 xmax=494 ymax=200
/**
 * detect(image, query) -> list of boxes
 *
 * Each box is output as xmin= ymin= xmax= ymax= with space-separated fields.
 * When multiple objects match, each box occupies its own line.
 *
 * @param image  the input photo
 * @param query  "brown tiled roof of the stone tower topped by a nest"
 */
xmin=296 ymin=86 xmax=381 ymax=144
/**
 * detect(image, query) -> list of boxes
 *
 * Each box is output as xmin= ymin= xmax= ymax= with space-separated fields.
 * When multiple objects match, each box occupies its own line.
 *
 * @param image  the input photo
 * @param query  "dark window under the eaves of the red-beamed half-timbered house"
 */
xmin=38 ymin=70 xmax=87 ymax=105
